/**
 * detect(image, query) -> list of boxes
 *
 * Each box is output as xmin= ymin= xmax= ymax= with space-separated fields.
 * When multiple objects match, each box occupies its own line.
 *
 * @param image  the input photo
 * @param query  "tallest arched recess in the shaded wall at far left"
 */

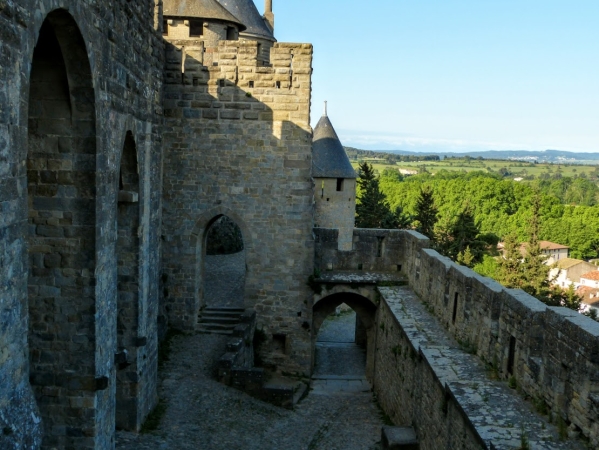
xmin=27 ymin=10 xmax=98 ymax=448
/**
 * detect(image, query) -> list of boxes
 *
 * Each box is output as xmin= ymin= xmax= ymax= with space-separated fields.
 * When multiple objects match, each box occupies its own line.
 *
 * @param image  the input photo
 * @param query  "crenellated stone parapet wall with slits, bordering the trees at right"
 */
xmin=315 ymin=229 xmax=599 ymax=446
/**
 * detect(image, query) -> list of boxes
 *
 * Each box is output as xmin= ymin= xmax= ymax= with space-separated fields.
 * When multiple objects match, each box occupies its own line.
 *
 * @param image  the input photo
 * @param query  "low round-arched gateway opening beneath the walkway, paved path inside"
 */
xmin=312 ymin=292 xmax=376 ymax=379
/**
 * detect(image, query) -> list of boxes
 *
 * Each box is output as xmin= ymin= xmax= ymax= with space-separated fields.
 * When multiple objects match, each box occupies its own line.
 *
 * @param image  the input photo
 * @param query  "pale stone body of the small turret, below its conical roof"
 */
xmin=314 ymin=178 xmax=356 ymax=251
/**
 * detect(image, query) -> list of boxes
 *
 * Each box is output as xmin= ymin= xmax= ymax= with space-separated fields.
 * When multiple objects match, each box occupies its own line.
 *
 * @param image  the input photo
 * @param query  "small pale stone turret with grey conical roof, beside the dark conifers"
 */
xmin=312 ymin=103 xmax=356 ymax=251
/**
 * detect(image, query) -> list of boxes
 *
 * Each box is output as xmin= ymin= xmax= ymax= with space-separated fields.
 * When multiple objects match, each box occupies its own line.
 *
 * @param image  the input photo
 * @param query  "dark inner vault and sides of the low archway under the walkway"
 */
xmin=312 ymin=286 xmax=376 ymax=380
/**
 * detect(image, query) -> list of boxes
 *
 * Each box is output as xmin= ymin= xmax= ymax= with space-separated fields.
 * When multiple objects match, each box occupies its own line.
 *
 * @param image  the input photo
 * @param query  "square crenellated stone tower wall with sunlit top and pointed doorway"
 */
xmin=163 ymin=40 xmax=313 ymax=372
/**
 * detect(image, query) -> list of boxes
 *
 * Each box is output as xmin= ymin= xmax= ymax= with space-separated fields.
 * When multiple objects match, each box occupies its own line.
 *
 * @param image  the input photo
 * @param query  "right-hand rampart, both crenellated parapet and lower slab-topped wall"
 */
xmin=315 ymin=229 xmax=599 ymax=449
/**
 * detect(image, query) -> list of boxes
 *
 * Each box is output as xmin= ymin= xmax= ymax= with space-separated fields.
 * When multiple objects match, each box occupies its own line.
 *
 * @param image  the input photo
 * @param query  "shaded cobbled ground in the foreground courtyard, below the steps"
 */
xmin=116 ymin=326 xmax=383 ymax=450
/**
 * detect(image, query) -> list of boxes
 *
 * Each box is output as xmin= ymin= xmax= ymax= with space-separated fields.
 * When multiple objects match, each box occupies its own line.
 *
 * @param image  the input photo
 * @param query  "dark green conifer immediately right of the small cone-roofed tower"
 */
xmin=356 ymin=162 xmax=397 ymax=228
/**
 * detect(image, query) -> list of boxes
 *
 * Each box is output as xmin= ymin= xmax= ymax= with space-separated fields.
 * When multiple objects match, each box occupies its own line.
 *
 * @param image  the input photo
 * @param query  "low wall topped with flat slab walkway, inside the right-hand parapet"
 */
xmin=374 ymin=287 xmax=584 ymax=450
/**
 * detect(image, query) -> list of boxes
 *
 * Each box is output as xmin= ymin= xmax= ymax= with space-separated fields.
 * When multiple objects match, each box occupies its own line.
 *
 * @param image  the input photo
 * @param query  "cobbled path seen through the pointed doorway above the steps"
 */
xmin=204 ymin=251 xmax=245 ymax=308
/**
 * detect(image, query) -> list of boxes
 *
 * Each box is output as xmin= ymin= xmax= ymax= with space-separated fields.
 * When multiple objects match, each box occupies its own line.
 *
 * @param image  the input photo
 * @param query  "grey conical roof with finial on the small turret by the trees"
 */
xmin=312 ymin=103 xmax=357 ymax=178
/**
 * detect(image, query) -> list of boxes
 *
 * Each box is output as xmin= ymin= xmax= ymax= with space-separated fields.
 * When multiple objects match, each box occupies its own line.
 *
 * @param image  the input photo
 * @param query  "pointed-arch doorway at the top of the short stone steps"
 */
xmin=203 ymin=215 xmax=246 ymax=308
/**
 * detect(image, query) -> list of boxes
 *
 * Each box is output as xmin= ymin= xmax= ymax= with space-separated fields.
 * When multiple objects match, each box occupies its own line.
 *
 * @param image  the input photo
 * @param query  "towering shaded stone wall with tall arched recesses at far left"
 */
xmin=0 ymin=0 xmax=163 ymax=449
